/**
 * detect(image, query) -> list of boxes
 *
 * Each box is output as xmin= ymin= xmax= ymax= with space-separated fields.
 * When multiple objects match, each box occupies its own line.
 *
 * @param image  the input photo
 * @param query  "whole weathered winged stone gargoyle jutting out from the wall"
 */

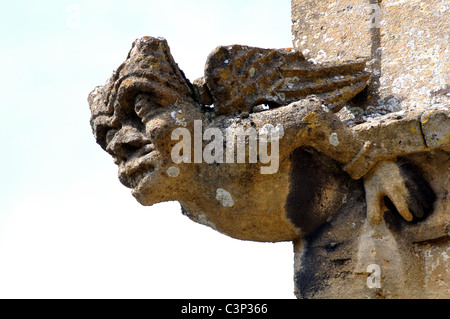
xmin=89 ymin=37 xmax=450 ymax=297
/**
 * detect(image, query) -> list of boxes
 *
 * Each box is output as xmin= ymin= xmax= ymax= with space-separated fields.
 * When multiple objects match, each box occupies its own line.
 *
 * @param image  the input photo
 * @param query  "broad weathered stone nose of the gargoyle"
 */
xmin=106 ymin=125 xmax=150 ymax=160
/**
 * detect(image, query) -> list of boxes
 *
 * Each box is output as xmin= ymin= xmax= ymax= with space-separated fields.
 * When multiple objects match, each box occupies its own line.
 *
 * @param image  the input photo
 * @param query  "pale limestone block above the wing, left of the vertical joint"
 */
xmin=292 ymin=0 xmax=374 ymax=62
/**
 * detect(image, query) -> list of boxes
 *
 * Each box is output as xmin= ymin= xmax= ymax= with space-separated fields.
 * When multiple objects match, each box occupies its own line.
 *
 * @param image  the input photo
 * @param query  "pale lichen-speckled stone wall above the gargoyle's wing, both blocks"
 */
xmin=292 ymin=0 xmax=450 ymax=113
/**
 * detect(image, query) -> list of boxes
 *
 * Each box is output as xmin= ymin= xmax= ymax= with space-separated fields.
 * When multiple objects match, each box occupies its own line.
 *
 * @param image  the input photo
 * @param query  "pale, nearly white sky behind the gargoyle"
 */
xmin=0 ymin=0 xmax=293 ymax=298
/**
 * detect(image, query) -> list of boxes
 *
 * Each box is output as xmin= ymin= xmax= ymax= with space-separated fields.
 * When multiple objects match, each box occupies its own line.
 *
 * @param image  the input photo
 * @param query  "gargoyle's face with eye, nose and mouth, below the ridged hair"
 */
xmin=106 ymin=93 xmax=200 ymax=201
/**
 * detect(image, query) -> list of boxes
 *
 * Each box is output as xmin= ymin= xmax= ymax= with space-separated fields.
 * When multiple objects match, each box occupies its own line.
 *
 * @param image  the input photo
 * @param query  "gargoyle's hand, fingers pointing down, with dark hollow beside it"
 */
xmin=364 ymin=161 xmax=436 ymax=225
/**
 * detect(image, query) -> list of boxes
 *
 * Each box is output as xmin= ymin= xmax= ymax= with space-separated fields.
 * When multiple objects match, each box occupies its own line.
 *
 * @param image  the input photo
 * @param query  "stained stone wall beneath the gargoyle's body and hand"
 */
xmin=295 ymin=150 xmax=450 ymax=298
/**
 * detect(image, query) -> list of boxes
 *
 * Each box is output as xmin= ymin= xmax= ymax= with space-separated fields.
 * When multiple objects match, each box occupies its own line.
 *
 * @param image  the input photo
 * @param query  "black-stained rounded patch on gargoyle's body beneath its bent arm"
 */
xmin=285 ymin=147 xmax=352 ymax=235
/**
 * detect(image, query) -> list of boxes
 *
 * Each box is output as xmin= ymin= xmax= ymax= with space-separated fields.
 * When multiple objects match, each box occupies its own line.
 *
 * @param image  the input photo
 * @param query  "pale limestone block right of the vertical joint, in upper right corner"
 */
xmin=379 ymin=0 xmax=450 ymax=107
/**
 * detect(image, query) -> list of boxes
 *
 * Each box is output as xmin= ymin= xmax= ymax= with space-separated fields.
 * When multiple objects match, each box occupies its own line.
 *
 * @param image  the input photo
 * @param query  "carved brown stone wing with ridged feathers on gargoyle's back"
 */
xmin=200 ymin=45 xmax=369 ymax=114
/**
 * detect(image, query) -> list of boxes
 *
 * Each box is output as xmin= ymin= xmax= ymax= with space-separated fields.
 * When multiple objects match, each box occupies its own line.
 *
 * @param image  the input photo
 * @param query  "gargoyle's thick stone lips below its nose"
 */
xmin=119 ymin=151 xmax=158 ymax=188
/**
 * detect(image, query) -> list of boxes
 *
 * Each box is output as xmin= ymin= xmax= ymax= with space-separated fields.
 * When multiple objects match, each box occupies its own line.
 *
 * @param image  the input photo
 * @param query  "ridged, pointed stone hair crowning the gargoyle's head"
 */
xmin=88 ymin=37 xmax=194 ymax=149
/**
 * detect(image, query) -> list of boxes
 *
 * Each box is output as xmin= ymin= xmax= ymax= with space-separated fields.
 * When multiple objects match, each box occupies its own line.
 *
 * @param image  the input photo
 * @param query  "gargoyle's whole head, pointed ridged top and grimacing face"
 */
xmin=89 ymin=37 xmax=201 ymax=205
